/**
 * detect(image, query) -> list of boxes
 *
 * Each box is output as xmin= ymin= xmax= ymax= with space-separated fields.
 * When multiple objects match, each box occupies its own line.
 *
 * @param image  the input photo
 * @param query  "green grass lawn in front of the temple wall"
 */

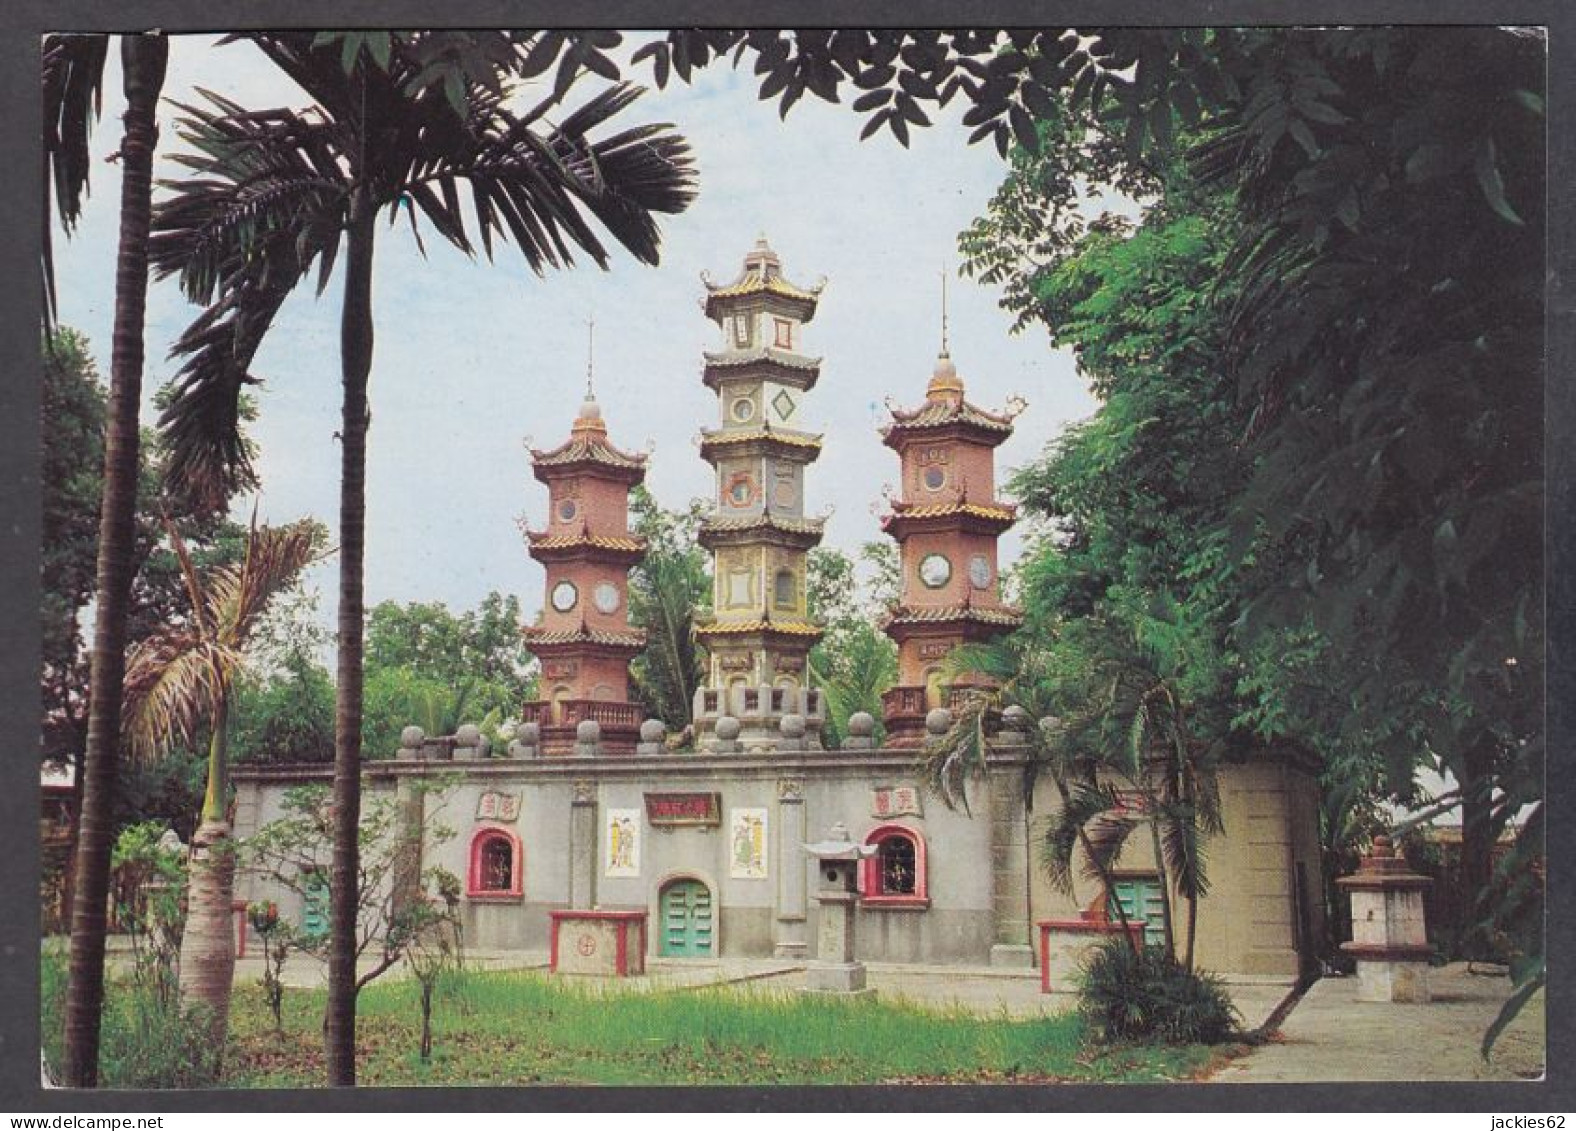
xmin=215 ymin=970 xmax=1236 ymax=1087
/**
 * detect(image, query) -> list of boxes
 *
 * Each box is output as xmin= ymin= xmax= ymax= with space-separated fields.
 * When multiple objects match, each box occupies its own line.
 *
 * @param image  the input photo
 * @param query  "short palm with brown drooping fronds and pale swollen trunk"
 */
xmin=123 ymin=510 xmax=323 ymax=1049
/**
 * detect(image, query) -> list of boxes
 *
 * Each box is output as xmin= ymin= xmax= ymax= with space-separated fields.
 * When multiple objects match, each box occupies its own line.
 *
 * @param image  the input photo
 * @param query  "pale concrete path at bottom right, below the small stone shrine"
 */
xmin=1214 ymin=962 xmax=1544 ymax=1084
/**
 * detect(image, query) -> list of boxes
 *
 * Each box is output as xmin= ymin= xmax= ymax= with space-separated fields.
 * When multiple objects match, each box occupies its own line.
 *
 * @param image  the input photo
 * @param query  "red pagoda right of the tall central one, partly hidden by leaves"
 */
xmin=881 ymin=345 xmax=1023 ymax=747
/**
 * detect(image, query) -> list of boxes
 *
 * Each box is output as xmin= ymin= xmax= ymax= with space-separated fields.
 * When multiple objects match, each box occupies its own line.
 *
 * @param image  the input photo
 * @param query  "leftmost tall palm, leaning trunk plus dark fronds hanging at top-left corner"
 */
xmin=41 ymin=35 xmax=169 ymax=1087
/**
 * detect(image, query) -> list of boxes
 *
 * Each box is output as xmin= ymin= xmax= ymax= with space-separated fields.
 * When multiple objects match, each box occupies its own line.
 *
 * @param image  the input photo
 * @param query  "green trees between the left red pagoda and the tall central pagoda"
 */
xmin=629 ymin=487 xmax=711 ymax=731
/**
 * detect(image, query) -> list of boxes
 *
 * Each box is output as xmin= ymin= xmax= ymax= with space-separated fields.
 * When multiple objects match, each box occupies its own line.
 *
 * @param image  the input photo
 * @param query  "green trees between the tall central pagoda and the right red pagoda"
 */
xmin=805 ymin=542 xmax=897 ymax=747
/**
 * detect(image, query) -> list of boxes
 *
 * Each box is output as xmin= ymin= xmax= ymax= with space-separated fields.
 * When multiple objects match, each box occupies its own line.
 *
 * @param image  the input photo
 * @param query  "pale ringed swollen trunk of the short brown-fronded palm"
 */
xmin=180 ymin=699 xmax=235 ymax=1059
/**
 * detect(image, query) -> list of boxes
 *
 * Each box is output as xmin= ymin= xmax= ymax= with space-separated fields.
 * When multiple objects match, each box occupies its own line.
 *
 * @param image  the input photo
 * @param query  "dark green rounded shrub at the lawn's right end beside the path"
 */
xmin=1078 ymin=939 xmax=1239 ymax=1044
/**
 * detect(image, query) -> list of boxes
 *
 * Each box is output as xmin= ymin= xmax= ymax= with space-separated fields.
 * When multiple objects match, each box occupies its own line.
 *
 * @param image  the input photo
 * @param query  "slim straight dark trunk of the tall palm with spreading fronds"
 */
xmin=325 ymin=184 xmax=377 ymax=1087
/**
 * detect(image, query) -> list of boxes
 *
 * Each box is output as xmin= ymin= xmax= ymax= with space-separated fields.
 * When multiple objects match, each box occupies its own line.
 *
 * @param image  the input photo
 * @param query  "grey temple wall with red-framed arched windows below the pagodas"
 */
xmin=236 ymin=751 xmax=1322 ymax=975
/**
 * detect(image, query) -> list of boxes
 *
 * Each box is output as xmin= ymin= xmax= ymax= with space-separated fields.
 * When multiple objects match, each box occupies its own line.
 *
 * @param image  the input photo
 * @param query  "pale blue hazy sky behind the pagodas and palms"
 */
xmin=57 ymin=36 xmax=1095 ymax=624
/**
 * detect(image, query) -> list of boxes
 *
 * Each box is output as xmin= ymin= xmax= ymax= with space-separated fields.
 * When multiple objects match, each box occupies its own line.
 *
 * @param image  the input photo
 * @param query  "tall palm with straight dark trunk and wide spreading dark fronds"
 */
xmin=154 ymin=32 xmax=693 ymax=1084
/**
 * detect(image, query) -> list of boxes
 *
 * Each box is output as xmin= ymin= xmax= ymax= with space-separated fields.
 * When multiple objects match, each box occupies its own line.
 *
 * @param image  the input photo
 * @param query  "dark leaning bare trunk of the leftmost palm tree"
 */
xmin=65 ymin=35 xmax=170 ymax=1088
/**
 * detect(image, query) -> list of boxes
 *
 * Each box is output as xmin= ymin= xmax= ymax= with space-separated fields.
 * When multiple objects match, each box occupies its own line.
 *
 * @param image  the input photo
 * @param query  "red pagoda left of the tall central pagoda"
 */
xmin=522 ymin=384 xmax=646 ymax=756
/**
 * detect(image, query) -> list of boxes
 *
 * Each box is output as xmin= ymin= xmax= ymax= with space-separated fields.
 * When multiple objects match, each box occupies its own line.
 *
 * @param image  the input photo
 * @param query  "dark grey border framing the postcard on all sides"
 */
xmin=0 ymin=0 xmax=1576 ymax=1114
